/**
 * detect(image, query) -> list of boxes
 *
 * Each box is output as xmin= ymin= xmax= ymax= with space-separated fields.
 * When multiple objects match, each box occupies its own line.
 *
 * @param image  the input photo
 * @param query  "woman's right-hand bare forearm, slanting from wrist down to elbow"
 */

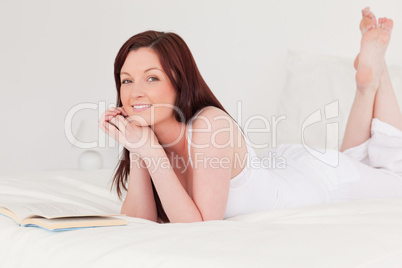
xmin=144 ymin=146 xmax=203 ymax=223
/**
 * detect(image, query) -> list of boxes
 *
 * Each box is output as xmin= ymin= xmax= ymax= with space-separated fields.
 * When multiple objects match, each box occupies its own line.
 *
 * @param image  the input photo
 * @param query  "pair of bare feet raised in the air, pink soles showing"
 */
xmin=355 ymin=8 xmax=393 ymax=92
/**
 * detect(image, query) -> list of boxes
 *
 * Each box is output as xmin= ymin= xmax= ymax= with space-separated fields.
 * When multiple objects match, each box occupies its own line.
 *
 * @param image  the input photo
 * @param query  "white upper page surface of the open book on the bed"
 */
xmin=0 ymin=200 xmax=117 ymax=220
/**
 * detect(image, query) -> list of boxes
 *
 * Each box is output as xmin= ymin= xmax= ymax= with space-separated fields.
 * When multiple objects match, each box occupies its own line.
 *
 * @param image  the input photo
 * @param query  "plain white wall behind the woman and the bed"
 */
xmin=0 ymin=0 xmax=402 ymax=174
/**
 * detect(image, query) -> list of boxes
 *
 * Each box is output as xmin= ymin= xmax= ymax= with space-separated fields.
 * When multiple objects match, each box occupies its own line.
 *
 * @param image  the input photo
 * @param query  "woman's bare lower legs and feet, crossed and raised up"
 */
xmin=340 ymin=8 xmax=402 ymax=152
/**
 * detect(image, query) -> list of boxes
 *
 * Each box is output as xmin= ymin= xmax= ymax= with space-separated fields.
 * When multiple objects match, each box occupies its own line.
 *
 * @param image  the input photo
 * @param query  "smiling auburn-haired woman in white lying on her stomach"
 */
xmin=99 ymin=8 xmax=402 ymax=222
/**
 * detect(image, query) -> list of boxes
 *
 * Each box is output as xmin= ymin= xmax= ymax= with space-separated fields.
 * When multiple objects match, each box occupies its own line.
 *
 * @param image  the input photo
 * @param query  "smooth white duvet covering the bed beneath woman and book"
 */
xmin=0 ymin=170 xmax=402 ymax=268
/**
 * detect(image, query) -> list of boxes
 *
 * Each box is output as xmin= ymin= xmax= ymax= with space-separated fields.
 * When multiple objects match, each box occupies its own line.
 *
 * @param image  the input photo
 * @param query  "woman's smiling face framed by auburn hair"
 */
xmin=120 ymin=47 xmax=176 ymax=126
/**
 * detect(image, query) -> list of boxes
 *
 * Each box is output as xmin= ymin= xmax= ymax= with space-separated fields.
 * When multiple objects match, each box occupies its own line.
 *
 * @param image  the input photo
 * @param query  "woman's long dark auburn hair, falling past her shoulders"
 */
xmin=112 ymin=31 xmax=227 ymax=222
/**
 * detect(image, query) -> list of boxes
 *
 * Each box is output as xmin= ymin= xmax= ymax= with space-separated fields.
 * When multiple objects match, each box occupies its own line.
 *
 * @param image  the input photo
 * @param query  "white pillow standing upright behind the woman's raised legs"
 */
xmin=276 ymin=51 xmax=402 ymax=152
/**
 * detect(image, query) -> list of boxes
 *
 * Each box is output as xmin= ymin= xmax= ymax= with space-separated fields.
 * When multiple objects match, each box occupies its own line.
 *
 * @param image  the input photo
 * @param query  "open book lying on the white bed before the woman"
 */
xmin=0 ymin=201 xmax=127 ymax=231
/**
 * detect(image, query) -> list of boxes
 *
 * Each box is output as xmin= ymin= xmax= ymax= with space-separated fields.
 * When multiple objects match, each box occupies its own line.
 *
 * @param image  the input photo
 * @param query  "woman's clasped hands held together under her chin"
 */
xmin=99 ymin=107 xmax=159 ymax=156
